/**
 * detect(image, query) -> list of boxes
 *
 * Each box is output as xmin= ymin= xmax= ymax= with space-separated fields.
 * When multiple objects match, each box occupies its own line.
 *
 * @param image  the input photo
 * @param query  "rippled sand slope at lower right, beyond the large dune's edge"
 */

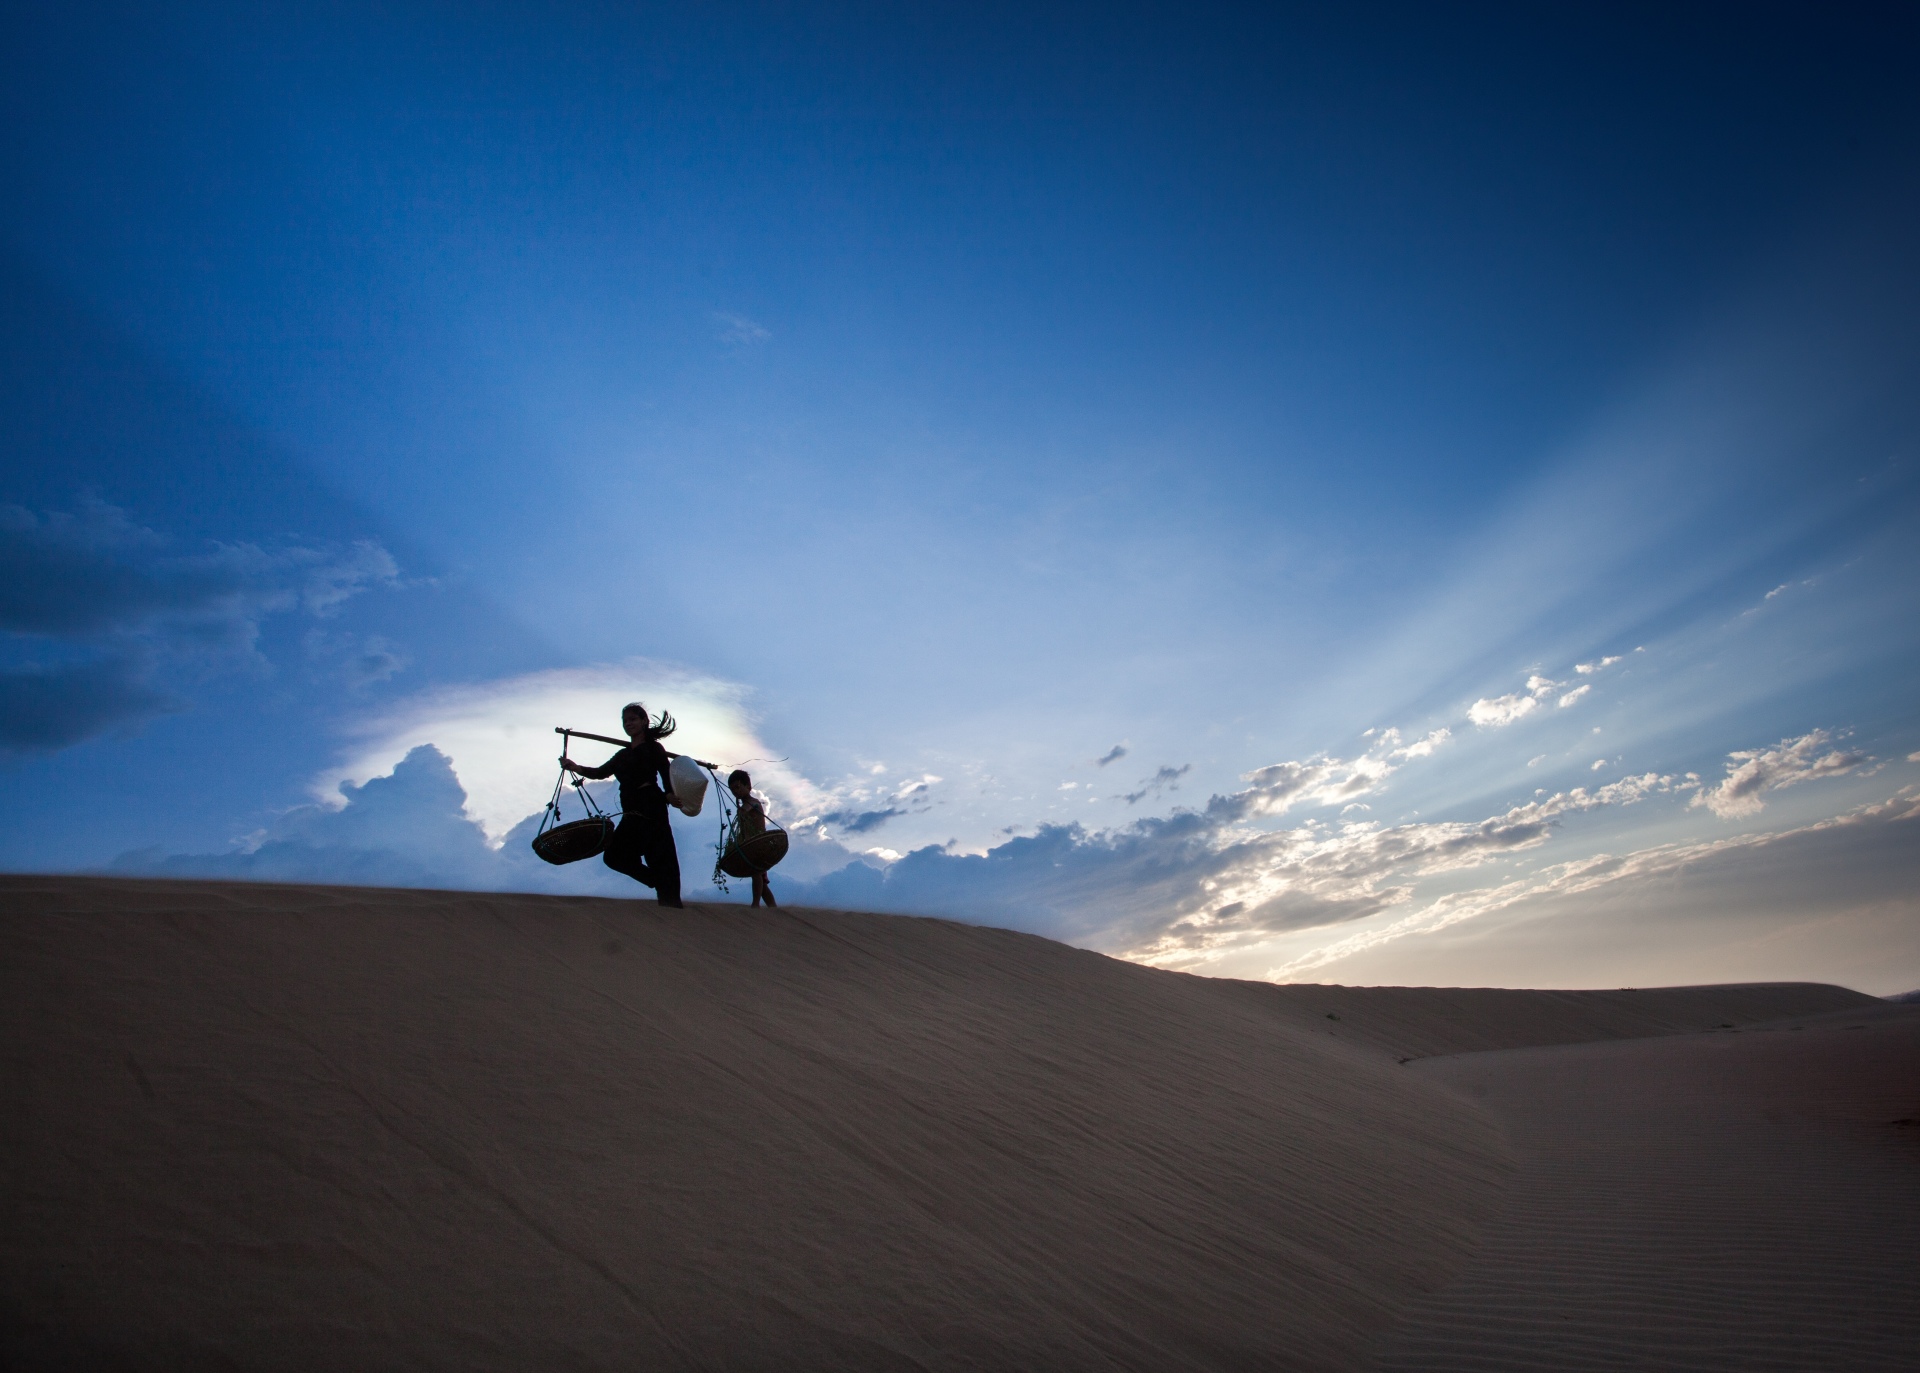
xmin=1380 ymin=1006 xmax=1920 ymax=1373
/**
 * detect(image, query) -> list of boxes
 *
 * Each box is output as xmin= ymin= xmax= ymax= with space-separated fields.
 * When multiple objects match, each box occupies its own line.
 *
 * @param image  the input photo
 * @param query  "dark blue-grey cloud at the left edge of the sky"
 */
xmin=0 ymin=501 xmax=397 ymax=751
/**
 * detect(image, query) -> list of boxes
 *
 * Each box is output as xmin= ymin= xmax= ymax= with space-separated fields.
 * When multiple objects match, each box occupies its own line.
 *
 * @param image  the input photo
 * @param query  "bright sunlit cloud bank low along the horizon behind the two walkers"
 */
xmin=115 ymin=645 xmax=1912 ymax=979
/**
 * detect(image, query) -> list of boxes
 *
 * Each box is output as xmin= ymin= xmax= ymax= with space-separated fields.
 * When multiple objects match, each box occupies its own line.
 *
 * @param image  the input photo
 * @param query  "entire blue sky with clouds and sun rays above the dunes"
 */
xmin=0 ymin=0 xmax=1920 ymax=993
